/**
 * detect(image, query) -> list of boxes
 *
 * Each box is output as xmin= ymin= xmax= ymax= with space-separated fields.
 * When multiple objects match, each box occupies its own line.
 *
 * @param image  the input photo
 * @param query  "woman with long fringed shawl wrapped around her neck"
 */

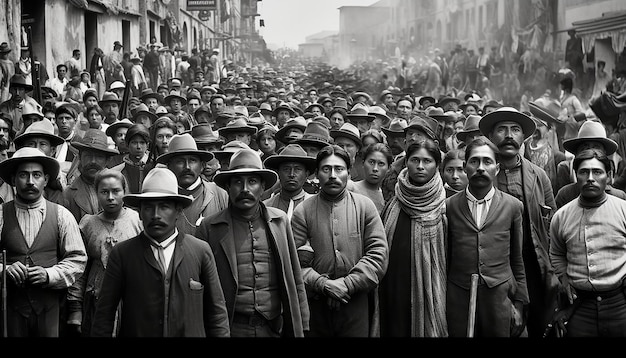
xmin=379 ymin=139 xmax=448 ymax=337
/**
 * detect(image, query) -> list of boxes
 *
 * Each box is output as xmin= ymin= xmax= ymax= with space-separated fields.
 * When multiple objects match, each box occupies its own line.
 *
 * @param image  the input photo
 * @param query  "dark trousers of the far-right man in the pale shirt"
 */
xmin=566 ymin=288 xmax=626 ymax=337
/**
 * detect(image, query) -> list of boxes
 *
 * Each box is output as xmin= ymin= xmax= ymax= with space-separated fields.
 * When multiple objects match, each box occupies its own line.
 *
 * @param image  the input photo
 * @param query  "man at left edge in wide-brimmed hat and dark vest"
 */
xmin=0 ymin=147 xmax=87 ymax=337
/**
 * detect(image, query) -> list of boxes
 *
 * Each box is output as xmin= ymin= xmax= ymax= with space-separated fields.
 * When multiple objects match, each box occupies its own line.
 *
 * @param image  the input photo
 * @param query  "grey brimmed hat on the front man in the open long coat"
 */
xmin=213 ymin=148 xmax=278 ymax=188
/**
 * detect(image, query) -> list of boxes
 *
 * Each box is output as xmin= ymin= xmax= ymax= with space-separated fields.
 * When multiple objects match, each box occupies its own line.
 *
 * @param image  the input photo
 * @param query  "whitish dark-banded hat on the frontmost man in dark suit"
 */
xmin=124 ymin=167 xmax=193 ymax=208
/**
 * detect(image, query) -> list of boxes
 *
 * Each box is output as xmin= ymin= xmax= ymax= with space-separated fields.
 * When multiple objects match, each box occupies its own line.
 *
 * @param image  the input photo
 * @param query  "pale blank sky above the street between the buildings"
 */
xmin=257 ymin=0 xmax=378 ymax=49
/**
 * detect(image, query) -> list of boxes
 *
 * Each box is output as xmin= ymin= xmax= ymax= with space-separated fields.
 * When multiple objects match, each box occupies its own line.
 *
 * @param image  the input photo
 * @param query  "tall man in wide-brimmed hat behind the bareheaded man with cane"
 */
xmin=478 ymin=107 xmax=557 ymax=337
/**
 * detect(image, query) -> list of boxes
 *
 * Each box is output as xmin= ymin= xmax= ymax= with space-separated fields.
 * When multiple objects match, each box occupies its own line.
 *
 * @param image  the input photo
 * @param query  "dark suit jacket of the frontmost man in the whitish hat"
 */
xmin=91 ymin=232 xmax=230 ymax=337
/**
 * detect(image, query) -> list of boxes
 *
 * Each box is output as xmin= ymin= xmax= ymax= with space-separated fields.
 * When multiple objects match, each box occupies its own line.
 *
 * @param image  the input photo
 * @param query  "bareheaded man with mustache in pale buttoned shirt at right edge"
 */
xmin=550 ymin=148 xmax=626 ymax=337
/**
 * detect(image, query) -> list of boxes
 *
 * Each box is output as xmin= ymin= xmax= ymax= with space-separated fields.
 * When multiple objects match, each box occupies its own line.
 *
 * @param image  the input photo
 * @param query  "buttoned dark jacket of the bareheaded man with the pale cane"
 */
xmin=446 ymin=189 xmax=529 ymax=304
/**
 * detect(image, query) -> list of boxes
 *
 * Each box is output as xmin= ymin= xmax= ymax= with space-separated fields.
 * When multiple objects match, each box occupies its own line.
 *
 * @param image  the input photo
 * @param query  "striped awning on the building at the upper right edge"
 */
xmin=572 ymin=11 xmax=626 ymax=53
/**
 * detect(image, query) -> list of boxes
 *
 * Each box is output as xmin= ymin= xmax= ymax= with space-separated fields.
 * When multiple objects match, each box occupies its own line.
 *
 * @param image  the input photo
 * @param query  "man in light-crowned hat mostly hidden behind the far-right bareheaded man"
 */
xmin=554 ymin=120 xmax=626 ymax=208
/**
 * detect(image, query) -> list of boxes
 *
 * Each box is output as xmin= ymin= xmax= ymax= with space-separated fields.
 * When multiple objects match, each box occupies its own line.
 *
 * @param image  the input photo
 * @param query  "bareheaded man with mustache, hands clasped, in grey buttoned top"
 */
xmin=291 ymin=145 xmax=389 ymax=337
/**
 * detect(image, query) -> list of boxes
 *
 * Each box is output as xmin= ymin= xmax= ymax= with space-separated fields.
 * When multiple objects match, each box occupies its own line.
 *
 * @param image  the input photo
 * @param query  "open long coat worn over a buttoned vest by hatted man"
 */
xmin=196 ymin=203 xmax=309 ymax=337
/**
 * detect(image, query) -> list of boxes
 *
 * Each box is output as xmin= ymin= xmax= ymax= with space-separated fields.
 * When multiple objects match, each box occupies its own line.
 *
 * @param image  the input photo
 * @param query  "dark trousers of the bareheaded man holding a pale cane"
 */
xmin=446 ymin=280 xmax=514 ymax=337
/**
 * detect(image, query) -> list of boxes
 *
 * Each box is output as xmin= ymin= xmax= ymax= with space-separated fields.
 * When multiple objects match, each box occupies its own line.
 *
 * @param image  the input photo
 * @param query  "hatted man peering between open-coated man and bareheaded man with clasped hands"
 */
xmin=263 ymin=144 xmax=315 ymax=220
